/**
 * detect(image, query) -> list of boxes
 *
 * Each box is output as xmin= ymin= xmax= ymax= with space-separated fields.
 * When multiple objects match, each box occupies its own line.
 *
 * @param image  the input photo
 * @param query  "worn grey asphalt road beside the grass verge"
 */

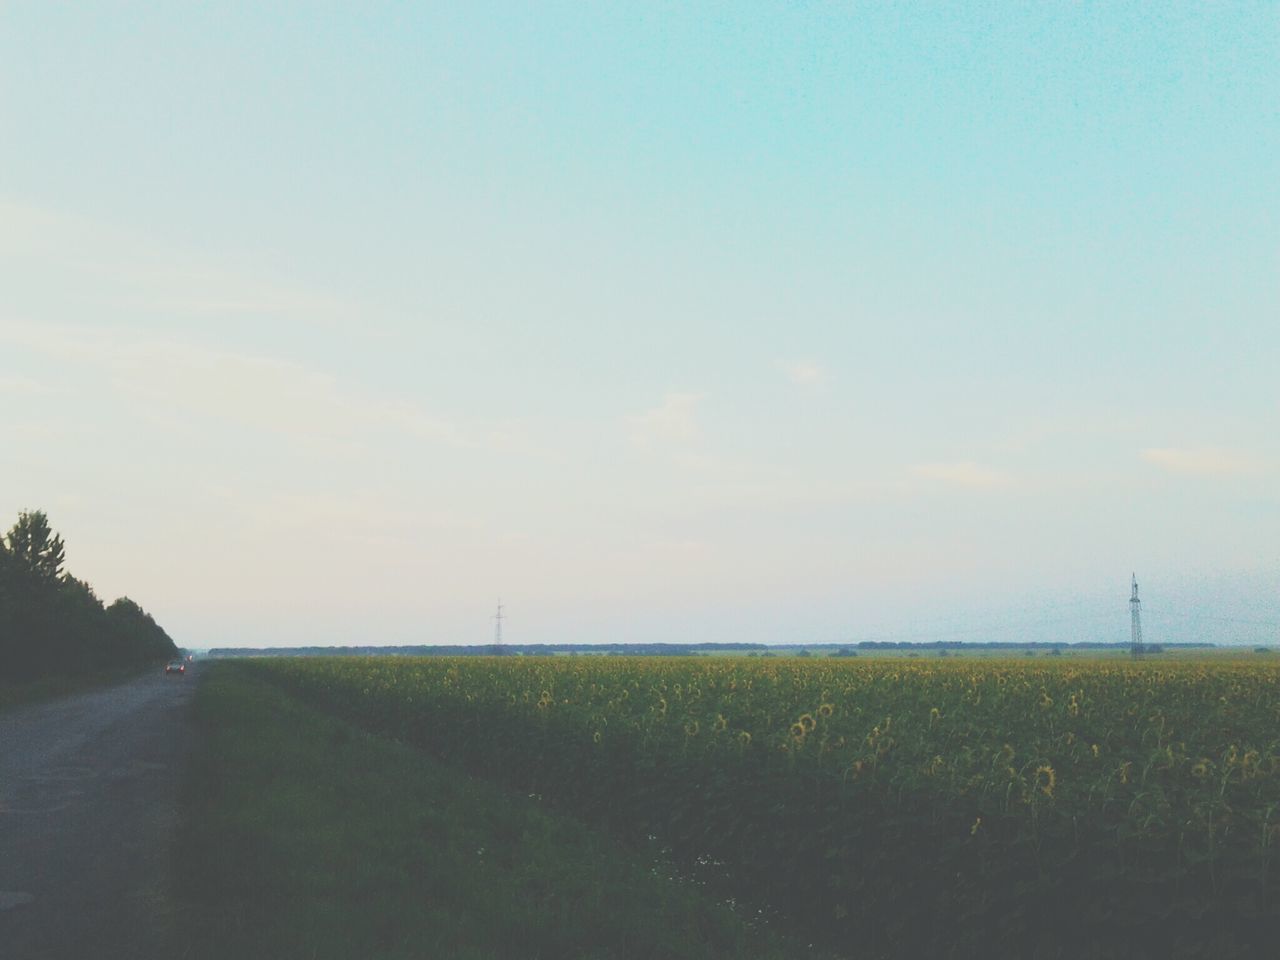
xmin=0 ymin=669 xmax=196 ymax=960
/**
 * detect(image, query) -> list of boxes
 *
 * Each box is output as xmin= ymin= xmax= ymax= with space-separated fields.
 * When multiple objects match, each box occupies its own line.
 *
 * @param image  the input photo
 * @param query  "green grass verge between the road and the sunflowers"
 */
xmin=183 ymin=663 xmax=839 ymax=960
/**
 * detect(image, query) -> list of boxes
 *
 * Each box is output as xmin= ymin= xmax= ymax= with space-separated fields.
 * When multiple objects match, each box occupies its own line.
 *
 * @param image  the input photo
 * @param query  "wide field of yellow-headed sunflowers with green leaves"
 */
xmin=255 ymin=657 xmax=1280 ymax=957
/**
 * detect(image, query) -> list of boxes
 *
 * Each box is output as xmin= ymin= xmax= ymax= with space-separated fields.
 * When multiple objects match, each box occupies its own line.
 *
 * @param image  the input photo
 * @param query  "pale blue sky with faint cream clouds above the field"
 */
xmin=0 ymin=0 xmax=1280 ymax=648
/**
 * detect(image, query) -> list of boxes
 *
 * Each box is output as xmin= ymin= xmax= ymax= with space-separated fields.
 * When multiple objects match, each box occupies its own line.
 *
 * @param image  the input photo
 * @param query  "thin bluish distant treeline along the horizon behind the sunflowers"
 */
xmin=207 ymin=640 xmax=1216 ymax=657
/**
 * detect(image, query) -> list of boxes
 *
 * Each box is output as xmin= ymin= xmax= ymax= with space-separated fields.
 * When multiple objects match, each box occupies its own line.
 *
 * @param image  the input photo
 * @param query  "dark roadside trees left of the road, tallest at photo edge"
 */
xmin=0 ymin=511 xmax=178 ymax=680
